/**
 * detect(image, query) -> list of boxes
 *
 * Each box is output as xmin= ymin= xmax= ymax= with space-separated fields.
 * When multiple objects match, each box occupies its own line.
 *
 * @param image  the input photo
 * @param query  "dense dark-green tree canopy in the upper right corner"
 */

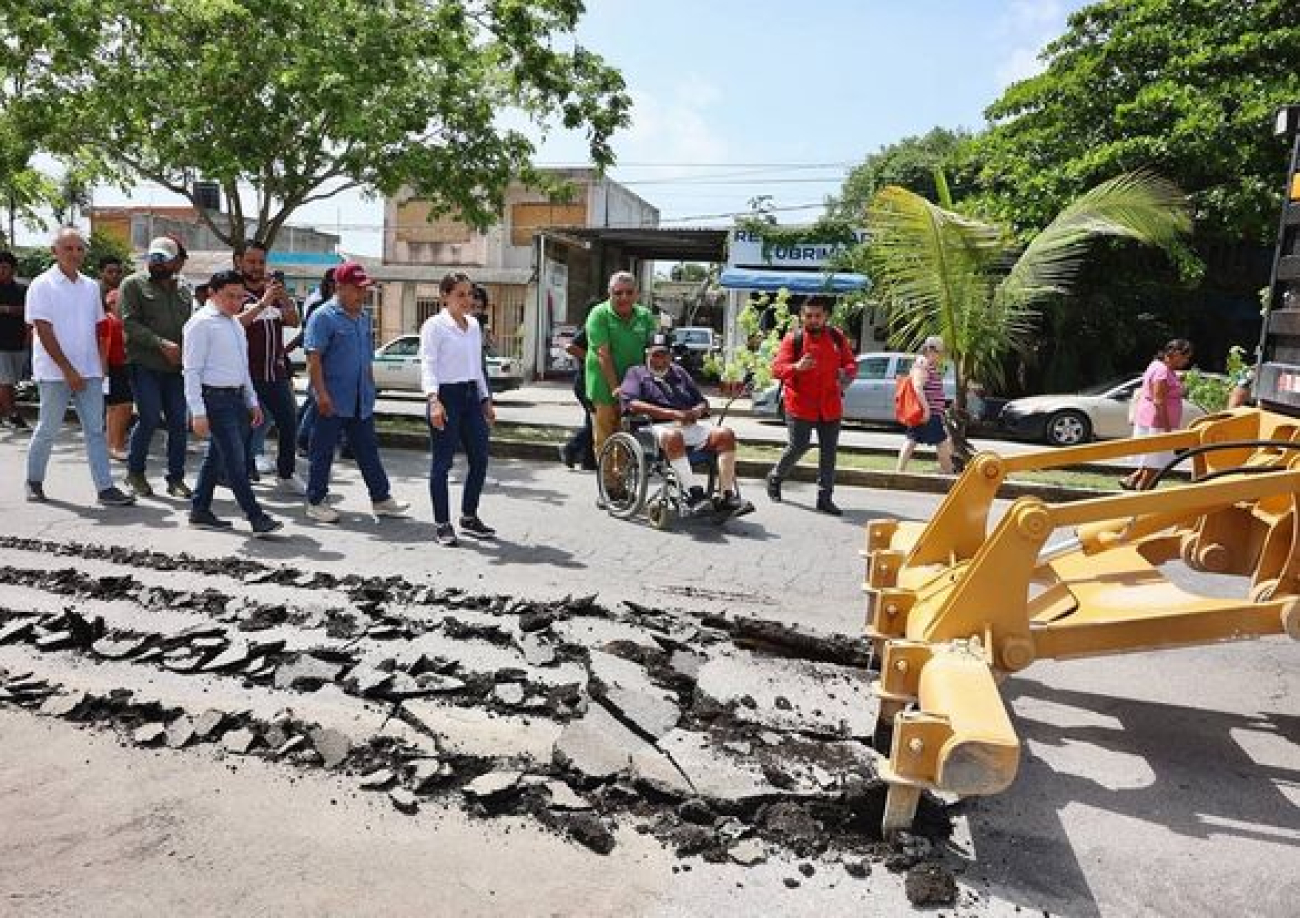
xmin=974 ymin=0 xmax=1300 ymax=243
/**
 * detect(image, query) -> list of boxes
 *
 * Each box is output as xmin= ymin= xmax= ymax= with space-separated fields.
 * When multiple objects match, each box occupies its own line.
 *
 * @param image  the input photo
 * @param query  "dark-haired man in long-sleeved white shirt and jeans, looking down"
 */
xmin=181 ymin=270 xmax=285 ymax=538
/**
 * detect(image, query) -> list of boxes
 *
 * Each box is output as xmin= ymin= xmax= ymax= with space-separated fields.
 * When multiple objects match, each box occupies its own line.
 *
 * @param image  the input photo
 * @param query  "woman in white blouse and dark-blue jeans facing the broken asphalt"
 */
xmin=420 ymin=272 xmax=497 ymax=545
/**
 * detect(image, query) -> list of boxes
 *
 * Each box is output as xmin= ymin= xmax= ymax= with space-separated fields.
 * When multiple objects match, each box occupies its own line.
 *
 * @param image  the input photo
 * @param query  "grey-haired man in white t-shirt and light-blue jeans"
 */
xmin=27 ymin=226 xmax=135 ymax=507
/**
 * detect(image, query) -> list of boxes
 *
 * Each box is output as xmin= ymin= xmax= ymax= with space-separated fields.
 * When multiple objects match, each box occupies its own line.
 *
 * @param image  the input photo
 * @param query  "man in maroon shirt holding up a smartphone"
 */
xmin=237 ymin=241 xmax=307 ymax=495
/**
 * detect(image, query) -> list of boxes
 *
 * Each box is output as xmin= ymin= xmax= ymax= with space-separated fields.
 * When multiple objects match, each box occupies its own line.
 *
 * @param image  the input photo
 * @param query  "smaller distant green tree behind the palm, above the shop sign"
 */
xmin=832 ymin=127 xmax=976 ymax=217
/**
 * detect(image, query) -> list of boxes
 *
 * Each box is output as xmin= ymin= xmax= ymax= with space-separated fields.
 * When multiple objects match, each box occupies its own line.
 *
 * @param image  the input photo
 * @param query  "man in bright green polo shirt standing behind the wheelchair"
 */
xmin=586 ymin=270 xmax=655 ymax=455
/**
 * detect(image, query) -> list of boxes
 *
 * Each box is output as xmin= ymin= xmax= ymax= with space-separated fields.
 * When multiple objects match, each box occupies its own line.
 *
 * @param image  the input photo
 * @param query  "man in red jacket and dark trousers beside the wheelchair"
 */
xmin=767 ymin=296 xmax=858 ymax=516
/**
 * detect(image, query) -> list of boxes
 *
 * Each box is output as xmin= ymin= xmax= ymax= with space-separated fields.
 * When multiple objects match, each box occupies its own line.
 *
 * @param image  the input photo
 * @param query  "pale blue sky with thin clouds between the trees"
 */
xmin=89 ymin=0 xmax=1084 ymax=255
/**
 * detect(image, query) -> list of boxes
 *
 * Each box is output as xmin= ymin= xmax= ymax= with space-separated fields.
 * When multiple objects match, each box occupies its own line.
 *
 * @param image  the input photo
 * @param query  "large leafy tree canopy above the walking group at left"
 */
xmin=0 ymin=0 xmax=631 ymax=247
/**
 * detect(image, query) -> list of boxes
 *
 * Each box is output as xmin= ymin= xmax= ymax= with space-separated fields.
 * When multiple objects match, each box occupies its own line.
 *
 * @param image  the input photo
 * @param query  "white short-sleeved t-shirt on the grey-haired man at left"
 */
xmin=27 ymin=265 xmax=104 ymax=382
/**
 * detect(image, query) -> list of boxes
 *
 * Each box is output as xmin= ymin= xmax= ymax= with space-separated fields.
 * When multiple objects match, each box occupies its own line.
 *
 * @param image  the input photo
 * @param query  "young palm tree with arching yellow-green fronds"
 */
xmin=863 ymin=172 xmax=1191 ymax=417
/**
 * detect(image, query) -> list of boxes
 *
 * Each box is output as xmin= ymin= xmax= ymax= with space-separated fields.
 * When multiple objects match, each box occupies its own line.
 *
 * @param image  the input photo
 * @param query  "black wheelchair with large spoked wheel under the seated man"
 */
xmin=595 ymin=415 xmax=740 ymax=529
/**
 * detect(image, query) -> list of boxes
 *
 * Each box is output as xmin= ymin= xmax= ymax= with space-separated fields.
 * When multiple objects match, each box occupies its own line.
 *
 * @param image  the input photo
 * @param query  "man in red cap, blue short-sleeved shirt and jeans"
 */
xmin=303 ymin=261 xmax=411 ymax=523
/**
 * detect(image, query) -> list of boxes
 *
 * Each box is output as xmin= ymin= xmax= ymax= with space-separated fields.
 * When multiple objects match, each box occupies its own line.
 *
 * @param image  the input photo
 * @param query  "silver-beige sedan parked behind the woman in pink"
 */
xmin=998 ymin=374 xmax=1205 ymax=446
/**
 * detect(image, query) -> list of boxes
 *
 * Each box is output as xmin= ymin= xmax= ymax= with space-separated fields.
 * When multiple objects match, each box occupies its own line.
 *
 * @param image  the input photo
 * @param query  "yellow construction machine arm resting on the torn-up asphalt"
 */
xmin=866 ymin=408 xmax=1300 ymax=833
